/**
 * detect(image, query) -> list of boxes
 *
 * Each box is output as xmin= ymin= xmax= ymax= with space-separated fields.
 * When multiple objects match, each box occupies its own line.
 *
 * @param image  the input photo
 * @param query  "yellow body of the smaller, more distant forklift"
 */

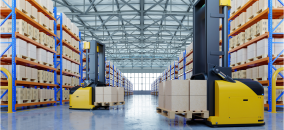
xmin=69 ymin=87 xmax=95 ymax=109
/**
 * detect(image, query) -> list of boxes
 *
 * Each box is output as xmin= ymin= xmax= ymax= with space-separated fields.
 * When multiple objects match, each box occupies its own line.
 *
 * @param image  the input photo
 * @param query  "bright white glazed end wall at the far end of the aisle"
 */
xmin=123 ymin=73 xmax=161 ymax=91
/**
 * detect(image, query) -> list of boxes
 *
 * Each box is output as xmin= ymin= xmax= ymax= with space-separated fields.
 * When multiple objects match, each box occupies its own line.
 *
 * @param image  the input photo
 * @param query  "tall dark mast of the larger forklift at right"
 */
xmin=191 ymin=0 xmax=232 ymax=116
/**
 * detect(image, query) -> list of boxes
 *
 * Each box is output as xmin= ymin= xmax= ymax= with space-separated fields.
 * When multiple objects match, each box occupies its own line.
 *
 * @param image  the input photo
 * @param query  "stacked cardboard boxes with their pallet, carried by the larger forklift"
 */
xmin=157 ymin=80 xmax=209 ymax=119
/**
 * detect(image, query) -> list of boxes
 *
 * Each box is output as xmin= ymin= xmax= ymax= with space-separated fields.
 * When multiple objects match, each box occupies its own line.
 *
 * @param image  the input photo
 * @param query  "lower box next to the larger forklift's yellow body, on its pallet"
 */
xmin=189 ymin=96 xmax=207 ymax=111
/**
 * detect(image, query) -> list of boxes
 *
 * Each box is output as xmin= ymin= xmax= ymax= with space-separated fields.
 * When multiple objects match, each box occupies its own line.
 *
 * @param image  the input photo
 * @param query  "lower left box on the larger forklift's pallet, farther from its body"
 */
xmin=165 ymin=95 xmax=189 ymax=111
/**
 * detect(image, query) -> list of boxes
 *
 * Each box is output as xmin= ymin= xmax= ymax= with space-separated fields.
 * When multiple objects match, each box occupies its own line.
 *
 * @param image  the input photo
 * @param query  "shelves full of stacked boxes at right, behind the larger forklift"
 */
xmin=229 ymin=0 xmax=284 ymax=107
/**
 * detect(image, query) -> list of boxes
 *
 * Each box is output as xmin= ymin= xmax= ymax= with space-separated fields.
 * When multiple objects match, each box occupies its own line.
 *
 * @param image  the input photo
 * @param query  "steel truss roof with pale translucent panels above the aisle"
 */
xmin=53 ymin=0 xmax=195 ymax=69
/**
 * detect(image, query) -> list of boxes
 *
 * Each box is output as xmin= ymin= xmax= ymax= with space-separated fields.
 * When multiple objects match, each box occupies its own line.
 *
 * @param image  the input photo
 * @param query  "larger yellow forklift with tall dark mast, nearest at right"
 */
xmin=191 ymin=0 xmax=265 ymax=126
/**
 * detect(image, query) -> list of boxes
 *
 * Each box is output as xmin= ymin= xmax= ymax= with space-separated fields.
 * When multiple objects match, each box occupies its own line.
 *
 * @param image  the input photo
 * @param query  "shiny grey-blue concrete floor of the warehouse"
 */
xmin=0 ymin=95 xmax=283 ymax=130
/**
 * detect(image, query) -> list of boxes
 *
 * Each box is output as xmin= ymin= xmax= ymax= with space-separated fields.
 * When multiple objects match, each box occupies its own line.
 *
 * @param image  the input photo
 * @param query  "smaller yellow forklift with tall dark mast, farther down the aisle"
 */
xmin=69 ymin=40 xmax=106 ymax=109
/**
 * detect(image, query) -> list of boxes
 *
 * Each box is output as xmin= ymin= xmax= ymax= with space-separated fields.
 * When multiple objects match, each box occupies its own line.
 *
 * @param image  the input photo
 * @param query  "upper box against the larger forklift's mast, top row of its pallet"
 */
xmin=189 ymin=80 xmax=207 ymax=96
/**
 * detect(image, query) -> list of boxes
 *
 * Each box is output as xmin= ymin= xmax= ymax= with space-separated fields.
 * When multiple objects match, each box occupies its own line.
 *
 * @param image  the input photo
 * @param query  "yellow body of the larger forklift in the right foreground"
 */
xmin=207 ymin=80 xmax=264 ymax=126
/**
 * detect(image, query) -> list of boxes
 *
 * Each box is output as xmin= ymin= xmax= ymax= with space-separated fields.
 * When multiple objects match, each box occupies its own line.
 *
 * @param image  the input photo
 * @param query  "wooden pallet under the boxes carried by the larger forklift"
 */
xmin=156 ymin=107 xmax=209 ymax=119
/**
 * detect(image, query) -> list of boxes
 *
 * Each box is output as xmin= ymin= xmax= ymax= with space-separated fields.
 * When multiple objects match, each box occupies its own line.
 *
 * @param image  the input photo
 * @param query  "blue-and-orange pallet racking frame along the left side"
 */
xmin=0 ymin=0 xmax=80 ymax=112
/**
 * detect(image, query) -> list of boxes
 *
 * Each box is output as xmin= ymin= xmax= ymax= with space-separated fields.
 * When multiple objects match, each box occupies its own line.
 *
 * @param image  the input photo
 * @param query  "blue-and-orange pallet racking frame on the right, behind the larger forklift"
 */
xmin=228 ymin=0 xmax=284 ymax=112
